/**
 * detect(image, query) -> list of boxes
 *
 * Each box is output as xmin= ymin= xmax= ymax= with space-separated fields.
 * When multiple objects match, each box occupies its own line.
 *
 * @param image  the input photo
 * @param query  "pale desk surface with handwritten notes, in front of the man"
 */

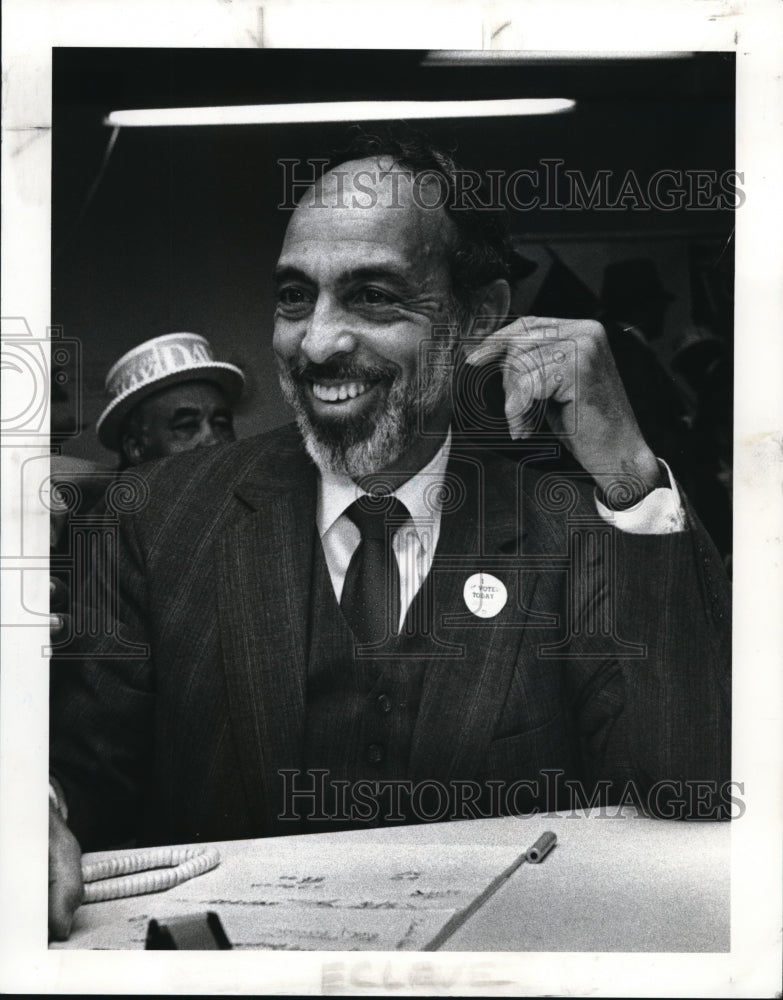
xmin=50 ymin=811 xmax=730 ymax=952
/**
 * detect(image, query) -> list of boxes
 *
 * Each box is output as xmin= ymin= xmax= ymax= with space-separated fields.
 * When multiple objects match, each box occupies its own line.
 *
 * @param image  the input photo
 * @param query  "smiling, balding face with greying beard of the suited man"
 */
xmin=274 ymin=158 xmax=468 ymax=478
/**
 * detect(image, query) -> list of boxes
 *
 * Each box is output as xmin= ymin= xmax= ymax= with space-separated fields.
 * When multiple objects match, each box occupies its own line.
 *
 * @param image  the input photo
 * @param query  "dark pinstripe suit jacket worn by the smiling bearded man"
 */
xmin=51 ymin=420 xmax=730 ymax=846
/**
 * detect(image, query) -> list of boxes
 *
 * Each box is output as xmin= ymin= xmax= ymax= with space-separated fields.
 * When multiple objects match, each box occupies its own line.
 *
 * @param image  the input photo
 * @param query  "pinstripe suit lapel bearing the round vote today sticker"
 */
xmin=411 ymin=454 xmax=535 ymax=781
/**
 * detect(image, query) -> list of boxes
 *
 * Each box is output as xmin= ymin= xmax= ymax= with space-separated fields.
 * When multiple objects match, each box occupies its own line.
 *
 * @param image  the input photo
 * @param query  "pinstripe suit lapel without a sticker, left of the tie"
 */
xmin=216 ymin=444 xmax=316 ymax=833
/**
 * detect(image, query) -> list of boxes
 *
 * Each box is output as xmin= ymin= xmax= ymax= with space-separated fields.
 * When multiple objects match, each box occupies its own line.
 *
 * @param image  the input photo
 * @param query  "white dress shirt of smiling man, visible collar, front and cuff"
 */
xmin=316 ymin=431 xmax=685 ymax=629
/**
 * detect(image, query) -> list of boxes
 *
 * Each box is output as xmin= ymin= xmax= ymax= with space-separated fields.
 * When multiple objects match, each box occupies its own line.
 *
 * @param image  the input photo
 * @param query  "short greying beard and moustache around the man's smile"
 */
xmin=278 ymin=358 xmax=451 ymax=480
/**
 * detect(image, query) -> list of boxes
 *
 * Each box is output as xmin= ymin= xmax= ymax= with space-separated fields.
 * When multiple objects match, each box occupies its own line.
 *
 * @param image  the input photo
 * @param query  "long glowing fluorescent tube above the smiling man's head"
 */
xmin=104 ymin=97 xmax=576 ymax=128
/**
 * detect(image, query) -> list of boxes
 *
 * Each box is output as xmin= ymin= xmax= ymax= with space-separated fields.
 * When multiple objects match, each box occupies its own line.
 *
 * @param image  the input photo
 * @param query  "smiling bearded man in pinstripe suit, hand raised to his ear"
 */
xmin=50 ymin=131 xmax=729 ymax=936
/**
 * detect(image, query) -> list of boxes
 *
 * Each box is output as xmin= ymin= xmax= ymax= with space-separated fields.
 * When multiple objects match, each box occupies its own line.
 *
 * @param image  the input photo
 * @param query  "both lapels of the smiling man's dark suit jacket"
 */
xmin=216 ymin=434 xmax=536 ymax=833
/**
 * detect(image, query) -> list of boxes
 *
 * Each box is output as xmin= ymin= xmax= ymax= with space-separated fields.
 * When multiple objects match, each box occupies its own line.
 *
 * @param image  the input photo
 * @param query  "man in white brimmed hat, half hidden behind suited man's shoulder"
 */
xmin=97 ymin=333 xmax=244 ymax=467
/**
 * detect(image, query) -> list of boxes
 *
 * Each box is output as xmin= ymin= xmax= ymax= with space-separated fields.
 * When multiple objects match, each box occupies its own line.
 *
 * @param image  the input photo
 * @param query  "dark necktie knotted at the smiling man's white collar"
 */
xmin=340 ymin=496 xmax=410 ymax=643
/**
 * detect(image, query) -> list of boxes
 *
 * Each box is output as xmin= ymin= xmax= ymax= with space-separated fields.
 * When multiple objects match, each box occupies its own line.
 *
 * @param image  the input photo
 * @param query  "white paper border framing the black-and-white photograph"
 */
xmin=0 ymin=0 xmax=783 ymax=997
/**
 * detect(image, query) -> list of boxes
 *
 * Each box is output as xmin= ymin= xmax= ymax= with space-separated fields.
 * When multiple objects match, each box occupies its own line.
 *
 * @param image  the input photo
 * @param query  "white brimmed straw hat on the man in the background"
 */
xmin=96 ymin=333 xmax=245 ymax=451
